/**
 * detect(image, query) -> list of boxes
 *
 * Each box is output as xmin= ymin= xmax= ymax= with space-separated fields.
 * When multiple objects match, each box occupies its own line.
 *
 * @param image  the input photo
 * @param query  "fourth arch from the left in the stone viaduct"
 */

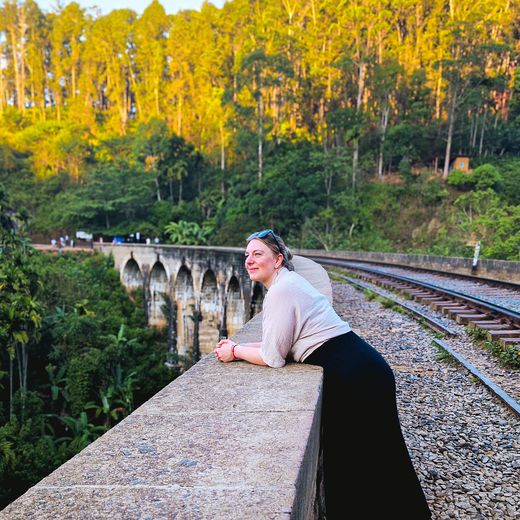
xmin=199 ymin=270 xmax=220 ymax=354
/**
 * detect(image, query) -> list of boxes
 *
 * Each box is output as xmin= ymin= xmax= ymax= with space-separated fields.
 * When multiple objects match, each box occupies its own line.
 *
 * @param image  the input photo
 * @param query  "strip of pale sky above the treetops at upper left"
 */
xmin=36 ymin=0 xmax=225 ymax=14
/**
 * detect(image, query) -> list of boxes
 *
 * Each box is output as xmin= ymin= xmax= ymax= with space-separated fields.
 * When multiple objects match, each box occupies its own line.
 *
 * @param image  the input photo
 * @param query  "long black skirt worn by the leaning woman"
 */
xmin=305 ymin=331 xmax=431 ymax=520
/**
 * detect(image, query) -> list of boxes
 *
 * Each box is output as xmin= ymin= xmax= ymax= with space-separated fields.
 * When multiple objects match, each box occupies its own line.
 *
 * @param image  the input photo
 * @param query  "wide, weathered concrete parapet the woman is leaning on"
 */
xmin=0 ymin=255 xmax=330 ymax=520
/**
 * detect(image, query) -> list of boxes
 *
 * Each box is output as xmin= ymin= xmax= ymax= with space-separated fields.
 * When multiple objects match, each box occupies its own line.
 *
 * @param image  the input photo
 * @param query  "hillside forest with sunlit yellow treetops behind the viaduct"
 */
xmin=0 ymin=0 xmax=520 ymax=260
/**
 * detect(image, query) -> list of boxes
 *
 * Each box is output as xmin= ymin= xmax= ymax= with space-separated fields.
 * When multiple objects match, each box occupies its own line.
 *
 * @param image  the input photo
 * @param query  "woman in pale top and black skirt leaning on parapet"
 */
xmin=215 ymin=229 xmax=431 ymax=520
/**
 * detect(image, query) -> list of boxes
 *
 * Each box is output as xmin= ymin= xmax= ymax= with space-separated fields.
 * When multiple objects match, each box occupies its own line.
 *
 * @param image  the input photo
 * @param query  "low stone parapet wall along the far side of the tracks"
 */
xmin=294 ymin=249 xmax=520 ymax=283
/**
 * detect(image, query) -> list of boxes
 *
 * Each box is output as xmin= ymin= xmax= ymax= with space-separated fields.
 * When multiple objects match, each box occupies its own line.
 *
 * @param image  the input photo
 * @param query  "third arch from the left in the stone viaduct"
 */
xmin=175 ymin=265 xmax=195 ymax=356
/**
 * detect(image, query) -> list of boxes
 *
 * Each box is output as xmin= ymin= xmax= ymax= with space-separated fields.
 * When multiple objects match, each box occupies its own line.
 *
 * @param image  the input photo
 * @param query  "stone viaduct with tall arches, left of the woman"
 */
xmin=94 ymin=244 xmax=264 ymax=357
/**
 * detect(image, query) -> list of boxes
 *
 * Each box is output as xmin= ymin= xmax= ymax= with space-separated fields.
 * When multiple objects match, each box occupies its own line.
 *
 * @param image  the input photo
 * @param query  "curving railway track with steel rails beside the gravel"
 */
xmin=310 ymin=257 xmax=520 ymax=416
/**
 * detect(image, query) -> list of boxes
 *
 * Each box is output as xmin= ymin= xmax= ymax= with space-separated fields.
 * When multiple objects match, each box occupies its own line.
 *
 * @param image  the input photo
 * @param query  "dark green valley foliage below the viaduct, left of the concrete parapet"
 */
xmin=0 ymin=248 xmax=177 ymax=506
